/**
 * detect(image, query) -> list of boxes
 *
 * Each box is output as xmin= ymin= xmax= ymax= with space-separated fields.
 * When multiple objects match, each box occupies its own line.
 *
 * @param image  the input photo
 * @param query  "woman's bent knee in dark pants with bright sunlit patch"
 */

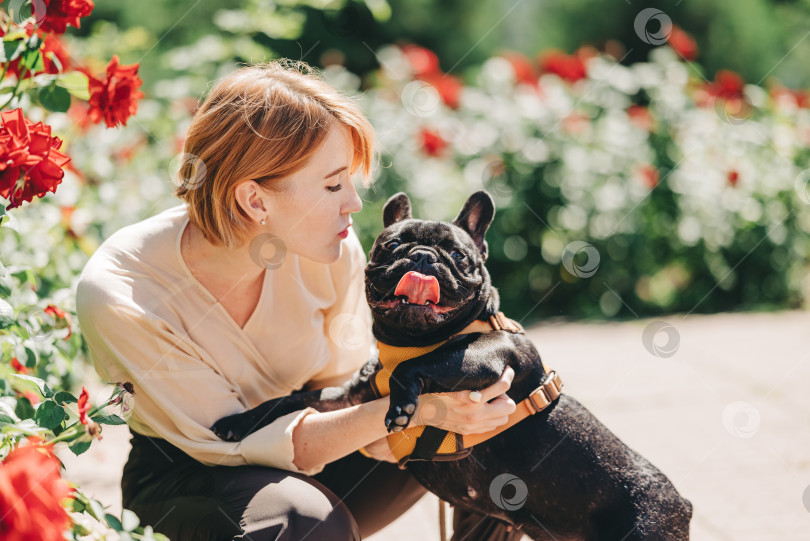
xmin=236 ymin=475 xmax=360 ymax=541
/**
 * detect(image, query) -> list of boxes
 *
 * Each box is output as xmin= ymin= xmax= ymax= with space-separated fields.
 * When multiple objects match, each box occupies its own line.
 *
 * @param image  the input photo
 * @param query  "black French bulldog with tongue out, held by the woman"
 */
xmin=212 ymin=192 xmax=692 ymax=541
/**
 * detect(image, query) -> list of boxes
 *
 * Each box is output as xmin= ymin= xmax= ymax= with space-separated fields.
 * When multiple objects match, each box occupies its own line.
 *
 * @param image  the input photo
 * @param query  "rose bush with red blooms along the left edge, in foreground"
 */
xmin=0 ymin=4 xmax=165 ymax=540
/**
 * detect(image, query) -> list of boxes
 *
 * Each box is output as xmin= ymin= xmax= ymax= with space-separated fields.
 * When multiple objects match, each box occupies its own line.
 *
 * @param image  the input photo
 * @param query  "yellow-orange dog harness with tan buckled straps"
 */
xmin=371 ymin=312 xmax=562 ymax=467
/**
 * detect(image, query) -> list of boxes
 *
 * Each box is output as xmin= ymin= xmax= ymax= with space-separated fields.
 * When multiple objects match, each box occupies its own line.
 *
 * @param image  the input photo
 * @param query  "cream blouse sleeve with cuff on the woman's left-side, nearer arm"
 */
xmin=76 ymin=278 xmax=323 ymax=475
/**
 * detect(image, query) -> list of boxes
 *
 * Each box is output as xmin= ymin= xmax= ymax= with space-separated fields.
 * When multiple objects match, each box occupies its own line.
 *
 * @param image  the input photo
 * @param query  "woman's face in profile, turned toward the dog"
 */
xmin=256 ymin=125 xmax=363 ymax=263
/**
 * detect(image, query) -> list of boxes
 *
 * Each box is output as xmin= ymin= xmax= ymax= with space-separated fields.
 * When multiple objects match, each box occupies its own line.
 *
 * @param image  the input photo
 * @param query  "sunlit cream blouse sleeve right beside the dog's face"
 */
xmin=307 ymin=228 xmax=377 ymax=389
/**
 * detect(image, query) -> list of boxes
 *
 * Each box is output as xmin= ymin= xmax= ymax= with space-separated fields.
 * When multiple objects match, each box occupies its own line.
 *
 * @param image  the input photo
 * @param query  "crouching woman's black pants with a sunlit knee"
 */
xmin=121 ymin=431 xmax=520 ymax=541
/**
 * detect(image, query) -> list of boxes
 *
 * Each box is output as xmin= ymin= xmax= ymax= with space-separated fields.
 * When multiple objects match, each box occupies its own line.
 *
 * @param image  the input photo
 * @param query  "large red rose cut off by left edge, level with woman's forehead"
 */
xmin=0 ymin=109 xmax=70 ymax=210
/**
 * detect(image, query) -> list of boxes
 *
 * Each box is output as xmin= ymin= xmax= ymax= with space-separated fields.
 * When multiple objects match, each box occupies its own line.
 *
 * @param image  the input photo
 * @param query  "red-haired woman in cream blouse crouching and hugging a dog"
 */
xmin=77 ymin=62 xmax=515 ymax=541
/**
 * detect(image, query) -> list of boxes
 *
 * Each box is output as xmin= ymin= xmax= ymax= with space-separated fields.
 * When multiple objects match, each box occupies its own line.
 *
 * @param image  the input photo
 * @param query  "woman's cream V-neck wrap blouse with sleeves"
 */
xmin=76 ymin=203 xmax=376 ymax=475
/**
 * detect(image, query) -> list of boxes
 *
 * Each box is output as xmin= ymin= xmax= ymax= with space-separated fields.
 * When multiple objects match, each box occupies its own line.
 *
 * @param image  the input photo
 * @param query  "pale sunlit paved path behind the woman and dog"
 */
xmin=60 ymin=312 xmax=810 ymax=541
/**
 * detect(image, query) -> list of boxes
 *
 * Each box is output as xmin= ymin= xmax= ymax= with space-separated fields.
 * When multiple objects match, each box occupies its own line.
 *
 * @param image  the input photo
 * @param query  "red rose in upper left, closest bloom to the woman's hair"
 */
xmin=78 ymin=55 xmax=143 ymax=128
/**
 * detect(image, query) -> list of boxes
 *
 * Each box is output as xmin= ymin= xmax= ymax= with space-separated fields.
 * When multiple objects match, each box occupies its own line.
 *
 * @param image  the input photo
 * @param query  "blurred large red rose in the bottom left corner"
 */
xmin=0 ymin=438 xmax=73 ymax=541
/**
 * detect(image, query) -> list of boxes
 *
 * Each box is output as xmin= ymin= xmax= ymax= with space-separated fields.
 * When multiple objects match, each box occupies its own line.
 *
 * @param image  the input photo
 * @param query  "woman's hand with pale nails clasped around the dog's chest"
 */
xmin=414 ymin=366 xmax=517 ymax=434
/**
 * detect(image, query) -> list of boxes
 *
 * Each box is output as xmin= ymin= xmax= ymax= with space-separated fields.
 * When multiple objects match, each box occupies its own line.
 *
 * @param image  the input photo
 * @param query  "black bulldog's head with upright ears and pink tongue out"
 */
xmin=366 ymin=192 xmax=494 ymax=333
